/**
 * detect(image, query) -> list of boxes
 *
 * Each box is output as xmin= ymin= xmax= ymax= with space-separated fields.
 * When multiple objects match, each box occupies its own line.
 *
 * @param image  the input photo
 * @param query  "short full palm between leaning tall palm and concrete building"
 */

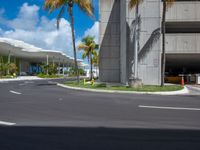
xmin=78 ymin=36 xmax=98 ymax=80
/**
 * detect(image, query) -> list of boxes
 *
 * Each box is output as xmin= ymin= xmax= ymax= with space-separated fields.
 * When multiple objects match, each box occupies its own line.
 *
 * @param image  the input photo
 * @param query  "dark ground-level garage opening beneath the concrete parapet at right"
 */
xmin=165 ymin=54 xmax=200 ymax=84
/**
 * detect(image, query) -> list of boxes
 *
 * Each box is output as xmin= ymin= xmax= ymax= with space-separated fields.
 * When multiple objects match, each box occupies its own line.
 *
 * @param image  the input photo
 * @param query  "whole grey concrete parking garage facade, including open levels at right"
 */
xmin=99 ymin=0 xmax=200 ymax=85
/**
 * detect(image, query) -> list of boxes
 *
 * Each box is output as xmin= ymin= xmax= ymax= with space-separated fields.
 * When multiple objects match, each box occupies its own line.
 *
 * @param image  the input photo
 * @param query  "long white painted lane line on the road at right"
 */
xmin=138 ymin=105 xmax=200 ymax=111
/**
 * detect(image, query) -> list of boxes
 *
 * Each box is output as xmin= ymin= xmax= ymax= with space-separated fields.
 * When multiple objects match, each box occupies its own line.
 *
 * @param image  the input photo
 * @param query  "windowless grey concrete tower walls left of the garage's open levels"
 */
xmin=99 ymin=0 xmax=161 ymax=84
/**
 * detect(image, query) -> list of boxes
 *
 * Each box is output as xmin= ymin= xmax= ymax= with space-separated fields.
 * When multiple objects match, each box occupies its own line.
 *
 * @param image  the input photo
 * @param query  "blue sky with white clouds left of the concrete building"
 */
xmin=0 ymin=0 xmax=99 ymax=58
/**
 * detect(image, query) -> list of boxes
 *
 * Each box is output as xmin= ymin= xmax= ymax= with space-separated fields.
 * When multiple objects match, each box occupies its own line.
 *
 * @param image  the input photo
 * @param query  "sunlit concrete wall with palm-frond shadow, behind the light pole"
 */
xmin=127 ymin=0 xmax=161 ymax=85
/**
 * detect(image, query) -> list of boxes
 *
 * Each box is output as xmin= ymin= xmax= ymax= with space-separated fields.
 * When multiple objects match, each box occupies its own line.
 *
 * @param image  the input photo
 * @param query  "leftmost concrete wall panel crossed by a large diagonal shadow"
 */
xmin=99 ymin=0 xmax=120 ymax=82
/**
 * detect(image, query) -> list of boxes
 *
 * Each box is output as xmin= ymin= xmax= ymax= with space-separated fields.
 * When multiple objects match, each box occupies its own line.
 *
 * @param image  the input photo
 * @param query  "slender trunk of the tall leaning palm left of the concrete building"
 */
xmin=69 ymin=4 xmax=80 ymax=84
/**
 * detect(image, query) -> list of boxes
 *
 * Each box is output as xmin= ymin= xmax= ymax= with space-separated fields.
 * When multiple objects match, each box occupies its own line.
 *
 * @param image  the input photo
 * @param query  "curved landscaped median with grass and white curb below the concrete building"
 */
xmin=58 ymin=81 xmax=188 ymax=95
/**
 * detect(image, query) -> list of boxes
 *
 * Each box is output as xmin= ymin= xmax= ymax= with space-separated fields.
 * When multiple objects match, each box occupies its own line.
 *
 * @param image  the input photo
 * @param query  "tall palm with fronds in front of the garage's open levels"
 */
xmin=161 ymin=0 xmax=174 ymax=86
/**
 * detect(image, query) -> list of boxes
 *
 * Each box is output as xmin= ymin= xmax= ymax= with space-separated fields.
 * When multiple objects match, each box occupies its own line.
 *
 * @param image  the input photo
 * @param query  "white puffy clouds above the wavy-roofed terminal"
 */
xmin=0 ymin=3 xmax=98 ymax=58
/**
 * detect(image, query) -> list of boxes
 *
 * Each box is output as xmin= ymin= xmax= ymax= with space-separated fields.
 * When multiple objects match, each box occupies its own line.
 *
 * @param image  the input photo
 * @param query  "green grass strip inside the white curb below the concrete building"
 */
xmin=65 ymin=81 xmax=183 ymax=92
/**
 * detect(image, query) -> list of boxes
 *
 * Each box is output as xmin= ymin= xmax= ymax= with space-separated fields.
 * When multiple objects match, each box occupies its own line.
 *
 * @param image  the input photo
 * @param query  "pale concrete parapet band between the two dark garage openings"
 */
xmin=166 ymin=33 xmax=200 ymax=54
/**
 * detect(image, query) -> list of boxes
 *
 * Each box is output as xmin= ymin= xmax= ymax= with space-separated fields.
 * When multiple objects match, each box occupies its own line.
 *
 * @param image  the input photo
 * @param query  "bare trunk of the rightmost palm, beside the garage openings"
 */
xmin=161 ymin=0 xmax=166 ymax=86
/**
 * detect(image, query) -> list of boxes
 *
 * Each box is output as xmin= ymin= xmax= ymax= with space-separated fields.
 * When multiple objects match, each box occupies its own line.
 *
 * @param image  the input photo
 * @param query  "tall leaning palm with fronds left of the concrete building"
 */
xmin=44 ymin=0 xmax=94 ymax=83
